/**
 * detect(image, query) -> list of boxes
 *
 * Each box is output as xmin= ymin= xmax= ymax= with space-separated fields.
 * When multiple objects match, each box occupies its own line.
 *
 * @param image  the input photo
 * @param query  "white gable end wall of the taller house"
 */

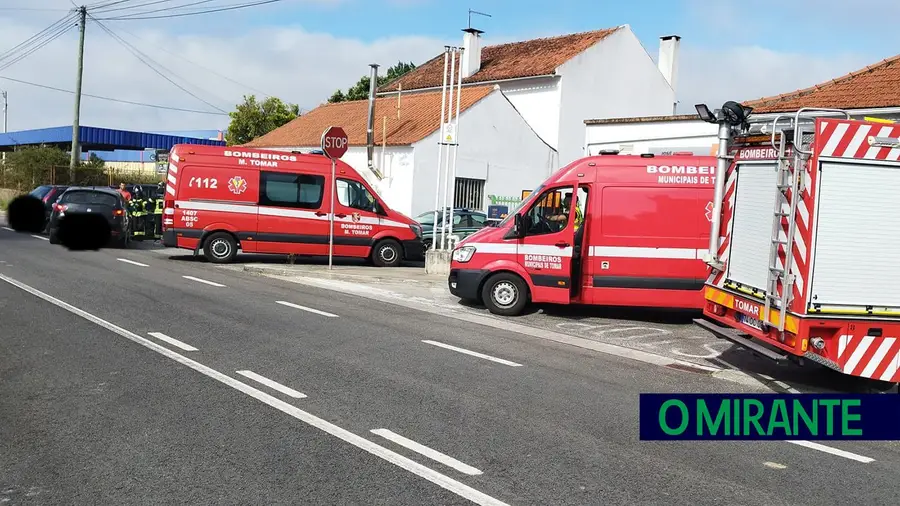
xmin=557 ymin=25 xmax=675 ymax=165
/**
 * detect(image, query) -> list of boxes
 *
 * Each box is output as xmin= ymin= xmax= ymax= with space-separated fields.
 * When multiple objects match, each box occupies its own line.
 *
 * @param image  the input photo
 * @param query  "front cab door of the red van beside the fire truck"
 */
xmin=517 ymin=183 xmax=576 ymax=304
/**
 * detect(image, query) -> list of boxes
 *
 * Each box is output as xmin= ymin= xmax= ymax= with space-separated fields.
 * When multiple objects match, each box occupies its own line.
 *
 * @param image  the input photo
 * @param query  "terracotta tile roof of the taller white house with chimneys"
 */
xmin=378 ymin=27 xmax=621 ymax=92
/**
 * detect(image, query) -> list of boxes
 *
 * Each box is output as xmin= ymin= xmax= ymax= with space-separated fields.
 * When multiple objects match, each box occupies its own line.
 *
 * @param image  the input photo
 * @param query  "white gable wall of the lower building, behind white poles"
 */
xmin=411 ymin=90 xmax=557 ymax=216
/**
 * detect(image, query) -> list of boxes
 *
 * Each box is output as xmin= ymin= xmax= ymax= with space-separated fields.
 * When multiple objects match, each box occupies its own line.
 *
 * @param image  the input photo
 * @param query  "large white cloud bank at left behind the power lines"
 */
xmin=0 ymin=0 xmax=444 ymax=130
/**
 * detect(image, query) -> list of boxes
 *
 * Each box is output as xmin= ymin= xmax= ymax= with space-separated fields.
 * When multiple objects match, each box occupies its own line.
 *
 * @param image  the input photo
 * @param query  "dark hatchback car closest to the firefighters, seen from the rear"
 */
xmin=49 ymin=187 xmax=131 ymax=248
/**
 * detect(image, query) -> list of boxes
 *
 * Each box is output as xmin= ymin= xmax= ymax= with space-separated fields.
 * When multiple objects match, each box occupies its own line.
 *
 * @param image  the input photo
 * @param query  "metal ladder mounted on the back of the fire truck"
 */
xmin=764 ymin=108 xmax=850 ymax=339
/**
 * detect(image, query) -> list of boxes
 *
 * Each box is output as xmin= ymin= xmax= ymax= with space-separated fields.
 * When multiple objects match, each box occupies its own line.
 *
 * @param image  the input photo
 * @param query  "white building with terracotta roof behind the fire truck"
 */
xmin=584 ymin=52 xmax=900 ymax=155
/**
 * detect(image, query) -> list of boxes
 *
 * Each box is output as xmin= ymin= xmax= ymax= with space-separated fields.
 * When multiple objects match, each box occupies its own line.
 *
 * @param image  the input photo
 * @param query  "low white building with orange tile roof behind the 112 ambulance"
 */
xmin=245 ymin=85 xmax=557 ymax=217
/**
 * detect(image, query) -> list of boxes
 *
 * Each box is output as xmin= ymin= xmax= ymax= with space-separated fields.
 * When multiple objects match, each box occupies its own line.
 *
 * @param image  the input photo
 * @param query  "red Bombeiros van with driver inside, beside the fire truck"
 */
xmin=448 ymin=154 xmax=716 ymax=316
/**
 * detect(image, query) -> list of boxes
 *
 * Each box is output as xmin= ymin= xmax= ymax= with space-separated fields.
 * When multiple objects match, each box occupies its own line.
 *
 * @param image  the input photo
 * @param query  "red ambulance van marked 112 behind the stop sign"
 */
xmin=163 ymin=144 xmax=424 ymax=267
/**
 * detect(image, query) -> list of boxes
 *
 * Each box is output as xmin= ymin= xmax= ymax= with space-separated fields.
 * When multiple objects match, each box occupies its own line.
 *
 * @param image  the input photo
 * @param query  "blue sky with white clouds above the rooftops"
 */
xmin=0 ymin=0 xmax=900 ymax=131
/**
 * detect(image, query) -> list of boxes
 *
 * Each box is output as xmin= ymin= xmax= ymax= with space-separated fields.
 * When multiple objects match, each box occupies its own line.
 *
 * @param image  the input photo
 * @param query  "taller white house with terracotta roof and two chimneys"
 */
xmin=379 ymin=25 xmax=681 ymax=165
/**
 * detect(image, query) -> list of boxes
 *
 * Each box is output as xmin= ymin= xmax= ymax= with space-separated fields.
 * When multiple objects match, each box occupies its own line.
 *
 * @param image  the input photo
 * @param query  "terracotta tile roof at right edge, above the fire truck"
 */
xmin=744 ymin=55 xmax=900 ymax=113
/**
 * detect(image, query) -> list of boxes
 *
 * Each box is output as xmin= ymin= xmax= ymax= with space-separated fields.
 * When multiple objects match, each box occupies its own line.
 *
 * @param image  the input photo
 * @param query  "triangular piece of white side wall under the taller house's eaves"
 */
xmin=499 ymin=76 xmax=560 ymax=149
